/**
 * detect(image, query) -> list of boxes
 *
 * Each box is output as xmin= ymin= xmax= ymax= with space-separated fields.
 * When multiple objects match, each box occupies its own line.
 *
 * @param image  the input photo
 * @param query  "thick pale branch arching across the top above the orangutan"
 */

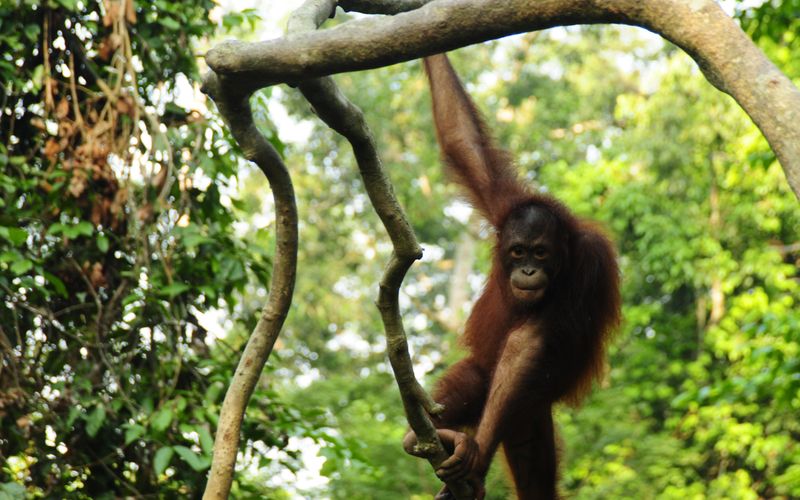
xmin=206 ymin=0 xmax=800 ymax=197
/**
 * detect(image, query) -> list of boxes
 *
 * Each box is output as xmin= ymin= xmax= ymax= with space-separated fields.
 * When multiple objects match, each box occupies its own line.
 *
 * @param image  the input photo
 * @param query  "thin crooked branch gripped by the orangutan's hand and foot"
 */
xmin=288 ymin=0 xmax=474 ymax=499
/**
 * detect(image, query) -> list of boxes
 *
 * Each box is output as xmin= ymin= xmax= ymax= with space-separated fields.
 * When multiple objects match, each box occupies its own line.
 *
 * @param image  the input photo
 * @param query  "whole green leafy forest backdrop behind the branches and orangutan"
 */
xmin=0 ymin=0 xmax=800 ymax=499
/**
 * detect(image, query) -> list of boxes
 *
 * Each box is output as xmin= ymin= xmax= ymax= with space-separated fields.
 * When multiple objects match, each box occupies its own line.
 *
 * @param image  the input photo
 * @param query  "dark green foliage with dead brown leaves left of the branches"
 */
xmin=0 ymin=0 xmax=312 ymax=498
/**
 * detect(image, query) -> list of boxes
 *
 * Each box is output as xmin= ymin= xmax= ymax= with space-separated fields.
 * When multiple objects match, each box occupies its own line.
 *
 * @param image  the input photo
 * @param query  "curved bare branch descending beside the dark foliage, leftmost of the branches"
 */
xmin=203 ymin=73 xmax=297 ymax=499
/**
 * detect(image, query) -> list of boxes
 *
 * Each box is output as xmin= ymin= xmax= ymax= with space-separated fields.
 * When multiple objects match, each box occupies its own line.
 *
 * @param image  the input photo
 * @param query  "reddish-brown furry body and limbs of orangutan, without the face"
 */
xmin=407 ymin=55 xmax=620 ymax=499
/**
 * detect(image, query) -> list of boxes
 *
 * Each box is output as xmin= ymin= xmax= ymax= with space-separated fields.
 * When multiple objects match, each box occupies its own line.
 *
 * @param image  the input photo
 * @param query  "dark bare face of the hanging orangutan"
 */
xmin=500 ymin=206 xmax=563 ymax=305
